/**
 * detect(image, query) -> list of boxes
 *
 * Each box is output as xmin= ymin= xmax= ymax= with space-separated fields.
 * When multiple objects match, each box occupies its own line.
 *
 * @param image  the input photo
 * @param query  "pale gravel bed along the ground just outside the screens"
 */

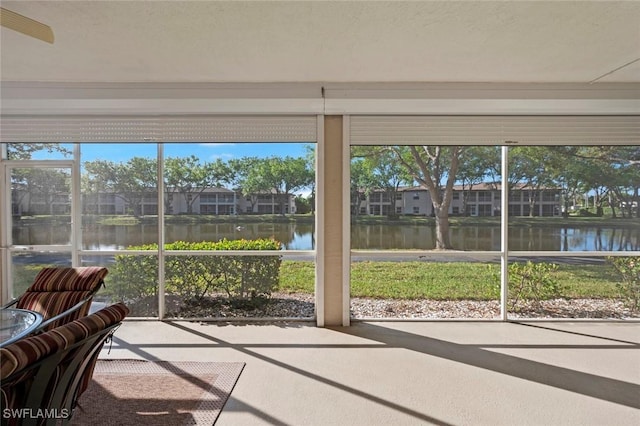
xmin=159 ymin=293 xmax=640 ymax=319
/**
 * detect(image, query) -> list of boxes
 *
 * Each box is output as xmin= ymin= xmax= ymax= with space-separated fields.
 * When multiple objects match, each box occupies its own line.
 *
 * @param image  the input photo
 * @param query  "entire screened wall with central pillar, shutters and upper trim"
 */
xmin=2 ymin=83 xmax=640 ymax=325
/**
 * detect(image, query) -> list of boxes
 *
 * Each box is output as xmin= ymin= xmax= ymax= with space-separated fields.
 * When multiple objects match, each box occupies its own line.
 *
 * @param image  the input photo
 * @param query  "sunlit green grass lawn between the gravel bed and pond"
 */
xmin=280 ymin=261 xmax=619 ymax=300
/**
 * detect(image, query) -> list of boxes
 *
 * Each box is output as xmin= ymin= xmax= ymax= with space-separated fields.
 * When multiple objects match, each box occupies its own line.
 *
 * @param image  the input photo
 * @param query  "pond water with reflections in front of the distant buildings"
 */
xmin=13 ymin=222 xmax=640 ymax=251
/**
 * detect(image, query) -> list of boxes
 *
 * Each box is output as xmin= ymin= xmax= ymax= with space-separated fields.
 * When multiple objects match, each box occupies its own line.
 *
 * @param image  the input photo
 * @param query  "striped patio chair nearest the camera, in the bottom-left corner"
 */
xmin=0 ymin=303 xmax=129 ymax=426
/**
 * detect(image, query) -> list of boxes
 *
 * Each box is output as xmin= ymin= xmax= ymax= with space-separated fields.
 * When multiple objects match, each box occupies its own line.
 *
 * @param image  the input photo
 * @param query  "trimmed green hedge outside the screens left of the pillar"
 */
xmin=106 ymin=239 xmax=282 ymax=301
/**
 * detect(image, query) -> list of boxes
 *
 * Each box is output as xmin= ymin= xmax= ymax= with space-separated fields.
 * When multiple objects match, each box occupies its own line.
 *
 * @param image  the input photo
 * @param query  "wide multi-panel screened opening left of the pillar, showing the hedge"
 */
xmin=4 ymin=134 xmax=316 ymax=319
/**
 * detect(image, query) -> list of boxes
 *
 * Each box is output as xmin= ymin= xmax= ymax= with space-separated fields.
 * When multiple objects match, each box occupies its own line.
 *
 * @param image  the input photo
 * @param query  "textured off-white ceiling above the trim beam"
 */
xmin=0 ymin=1 xmax=640 ymax=83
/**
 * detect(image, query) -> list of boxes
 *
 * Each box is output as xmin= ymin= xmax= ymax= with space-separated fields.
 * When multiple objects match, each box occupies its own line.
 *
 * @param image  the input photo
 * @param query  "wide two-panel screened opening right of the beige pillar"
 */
xmin=349 ymin=132 xmax=640 ymax=319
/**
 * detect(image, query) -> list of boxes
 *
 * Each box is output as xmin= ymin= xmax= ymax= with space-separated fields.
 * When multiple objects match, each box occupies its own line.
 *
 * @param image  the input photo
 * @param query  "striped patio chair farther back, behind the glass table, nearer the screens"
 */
xmin=5 ymin=266 xmax=109 ymax=332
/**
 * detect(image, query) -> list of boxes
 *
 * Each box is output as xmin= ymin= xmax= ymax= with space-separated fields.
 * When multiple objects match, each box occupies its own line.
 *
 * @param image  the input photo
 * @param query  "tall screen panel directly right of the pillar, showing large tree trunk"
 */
xmin=350 ymin=145 xmax=501 ymax=319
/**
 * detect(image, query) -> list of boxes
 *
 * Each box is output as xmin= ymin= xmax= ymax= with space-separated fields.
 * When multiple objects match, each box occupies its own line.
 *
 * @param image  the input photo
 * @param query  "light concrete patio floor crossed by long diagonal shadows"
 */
xmin=101 ymin=321 xmax=640 ymax=426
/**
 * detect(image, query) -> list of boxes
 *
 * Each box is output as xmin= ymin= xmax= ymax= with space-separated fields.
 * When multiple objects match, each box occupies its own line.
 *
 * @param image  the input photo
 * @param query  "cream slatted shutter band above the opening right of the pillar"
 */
xmin=350 ymin=116 xmax=640 ymax=145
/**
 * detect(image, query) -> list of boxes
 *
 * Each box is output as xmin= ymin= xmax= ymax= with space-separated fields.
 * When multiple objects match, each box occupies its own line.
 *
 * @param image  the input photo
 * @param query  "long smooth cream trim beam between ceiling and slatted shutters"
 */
xmin=0 ymin=81 xmax=640 ymax=115
